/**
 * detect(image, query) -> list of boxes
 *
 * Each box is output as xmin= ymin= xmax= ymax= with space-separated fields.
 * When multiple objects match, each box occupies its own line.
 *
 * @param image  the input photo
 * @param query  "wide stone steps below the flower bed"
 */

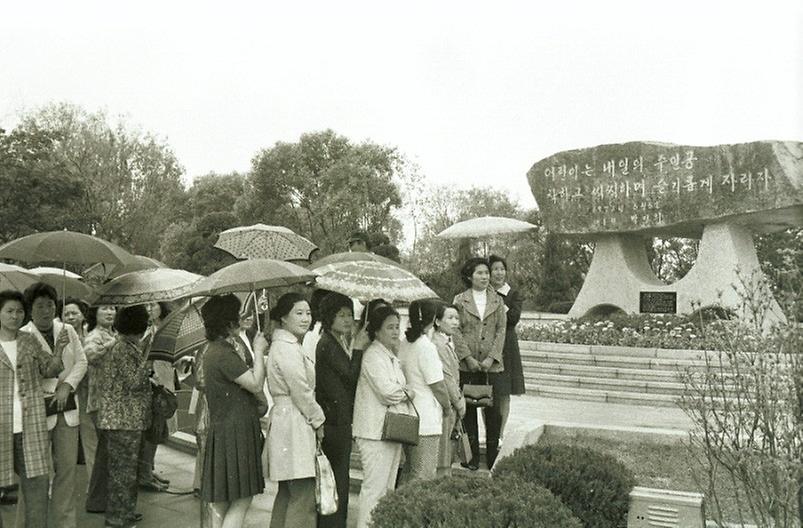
xmin=519 ymin=341 xmax=736 ymax=406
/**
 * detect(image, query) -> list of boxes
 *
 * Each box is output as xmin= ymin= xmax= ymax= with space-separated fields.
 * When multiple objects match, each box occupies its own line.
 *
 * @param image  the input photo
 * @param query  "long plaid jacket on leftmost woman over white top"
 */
xmin=0 ymin=332 xmax=64 ymax=486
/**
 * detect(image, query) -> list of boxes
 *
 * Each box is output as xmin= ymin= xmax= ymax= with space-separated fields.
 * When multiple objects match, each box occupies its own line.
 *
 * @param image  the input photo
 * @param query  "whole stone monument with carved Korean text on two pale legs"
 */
xmin=527 ymin=141 xmax=803 ymax=321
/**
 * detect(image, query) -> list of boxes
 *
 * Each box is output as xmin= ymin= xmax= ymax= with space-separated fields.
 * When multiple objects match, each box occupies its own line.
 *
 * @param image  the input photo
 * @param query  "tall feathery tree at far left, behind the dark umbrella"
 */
xmin=18 ymin=103 xmax=189 ymax=256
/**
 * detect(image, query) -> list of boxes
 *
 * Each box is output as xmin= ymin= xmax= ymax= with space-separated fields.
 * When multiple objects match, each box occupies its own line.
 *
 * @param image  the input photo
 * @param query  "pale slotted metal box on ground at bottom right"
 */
xmin=627 ymin=487 xmax=705 ymax=528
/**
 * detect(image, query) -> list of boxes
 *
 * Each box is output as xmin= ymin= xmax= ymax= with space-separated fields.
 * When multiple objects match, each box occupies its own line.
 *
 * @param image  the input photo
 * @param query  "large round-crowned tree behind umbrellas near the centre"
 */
xmin=237 ymin=130 xmax=402 ymax=252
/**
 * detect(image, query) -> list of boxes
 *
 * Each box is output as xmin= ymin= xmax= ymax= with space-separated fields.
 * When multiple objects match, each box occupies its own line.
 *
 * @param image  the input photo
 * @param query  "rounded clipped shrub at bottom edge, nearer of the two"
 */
xmin=371 ymin=475 xmax=582 ymax=528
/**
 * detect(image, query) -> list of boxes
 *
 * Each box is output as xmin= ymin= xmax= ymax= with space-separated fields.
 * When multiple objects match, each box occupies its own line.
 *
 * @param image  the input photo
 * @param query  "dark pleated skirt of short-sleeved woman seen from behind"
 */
xmin=201 ymin=417 xmax=265 ymax=502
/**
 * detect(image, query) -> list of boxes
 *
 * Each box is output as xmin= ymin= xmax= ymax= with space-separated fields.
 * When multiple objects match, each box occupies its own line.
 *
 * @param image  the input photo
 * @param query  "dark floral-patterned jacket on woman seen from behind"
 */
xmin=92 ymin=336 xmax=151 ymax=431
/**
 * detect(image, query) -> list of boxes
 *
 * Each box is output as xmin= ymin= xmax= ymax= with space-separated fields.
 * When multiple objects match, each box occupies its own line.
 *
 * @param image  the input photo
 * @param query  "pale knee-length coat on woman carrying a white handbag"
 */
xmin=267 ymin=329 xmax=325 ymax=481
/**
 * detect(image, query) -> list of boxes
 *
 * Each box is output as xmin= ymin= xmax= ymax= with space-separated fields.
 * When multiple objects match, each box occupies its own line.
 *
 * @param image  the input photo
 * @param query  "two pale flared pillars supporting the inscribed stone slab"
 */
xmin=569 ymin=223 xmax=785 ymax=324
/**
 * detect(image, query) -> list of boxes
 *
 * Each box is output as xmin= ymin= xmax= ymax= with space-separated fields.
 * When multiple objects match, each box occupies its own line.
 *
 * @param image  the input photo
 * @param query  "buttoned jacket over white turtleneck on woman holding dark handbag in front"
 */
xmin=452 ymin=286 xmax=507 ymax=372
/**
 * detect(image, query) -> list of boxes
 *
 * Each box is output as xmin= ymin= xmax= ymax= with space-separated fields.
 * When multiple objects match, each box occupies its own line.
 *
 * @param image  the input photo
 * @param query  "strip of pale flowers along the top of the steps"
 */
xmin=519 ymin=314 xmax=738 ymax=350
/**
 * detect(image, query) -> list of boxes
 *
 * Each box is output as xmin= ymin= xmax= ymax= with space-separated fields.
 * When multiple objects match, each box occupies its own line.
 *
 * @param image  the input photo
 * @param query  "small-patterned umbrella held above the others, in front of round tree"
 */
xmin=215 ymin=224 xmax=318 ymax=260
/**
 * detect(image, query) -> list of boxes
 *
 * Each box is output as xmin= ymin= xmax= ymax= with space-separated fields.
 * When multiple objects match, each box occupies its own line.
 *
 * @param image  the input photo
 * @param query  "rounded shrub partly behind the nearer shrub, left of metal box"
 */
xmin=494 ymin=445 xmax=636 ymax=528
